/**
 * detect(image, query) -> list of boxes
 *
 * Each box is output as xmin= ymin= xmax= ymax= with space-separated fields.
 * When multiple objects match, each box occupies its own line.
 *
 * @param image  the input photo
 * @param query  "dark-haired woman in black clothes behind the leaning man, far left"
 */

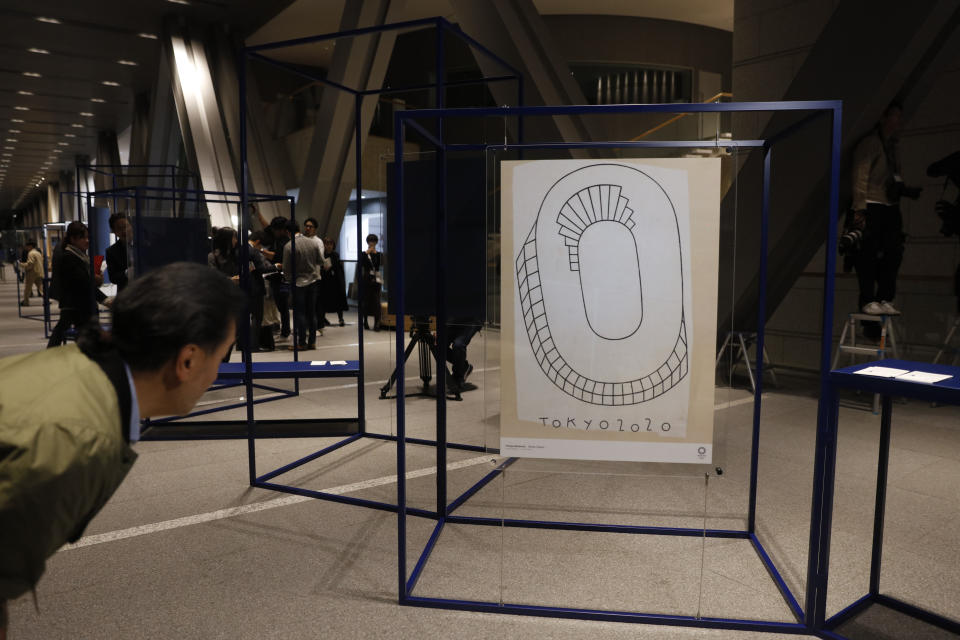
xmin=47 ymin=220 xmax=109 ymax=349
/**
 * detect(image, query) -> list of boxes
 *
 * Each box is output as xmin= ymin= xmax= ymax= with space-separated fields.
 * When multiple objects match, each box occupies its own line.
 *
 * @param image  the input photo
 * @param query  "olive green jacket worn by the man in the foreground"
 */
xmin=0 ymin=345 xmax=136 ymax=602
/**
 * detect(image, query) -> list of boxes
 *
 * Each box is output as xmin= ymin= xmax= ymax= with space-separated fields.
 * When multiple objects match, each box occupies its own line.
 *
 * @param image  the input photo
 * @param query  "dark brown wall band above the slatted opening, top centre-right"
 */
xmin=543 ymin=15 xmax=733 ymax=89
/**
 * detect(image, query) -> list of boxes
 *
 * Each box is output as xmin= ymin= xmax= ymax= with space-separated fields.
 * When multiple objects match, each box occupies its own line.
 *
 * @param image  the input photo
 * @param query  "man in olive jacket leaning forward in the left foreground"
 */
xmin=0 ymin=262 xmax=243 ymax=638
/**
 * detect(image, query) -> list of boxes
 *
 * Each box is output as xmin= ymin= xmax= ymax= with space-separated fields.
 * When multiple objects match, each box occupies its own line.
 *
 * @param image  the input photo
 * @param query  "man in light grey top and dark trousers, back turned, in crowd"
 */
xmin=283 ymin=220 xmax=323 ymax=349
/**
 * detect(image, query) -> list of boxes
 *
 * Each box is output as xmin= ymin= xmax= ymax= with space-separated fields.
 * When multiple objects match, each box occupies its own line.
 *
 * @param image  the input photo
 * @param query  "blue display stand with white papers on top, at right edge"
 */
xmin=813 ymin=359 xmax=960 ymax=638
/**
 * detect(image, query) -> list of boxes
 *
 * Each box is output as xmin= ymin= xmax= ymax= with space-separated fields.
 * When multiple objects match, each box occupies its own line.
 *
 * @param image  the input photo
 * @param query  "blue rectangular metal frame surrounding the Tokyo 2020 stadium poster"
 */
xmin=392 ymin=100 xmax=842 ymax=634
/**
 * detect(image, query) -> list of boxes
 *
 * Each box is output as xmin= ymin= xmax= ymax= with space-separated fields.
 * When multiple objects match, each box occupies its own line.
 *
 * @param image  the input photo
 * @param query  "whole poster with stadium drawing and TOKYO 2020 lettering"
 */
xmin=500 ymin=158 xmax=720 ymax=463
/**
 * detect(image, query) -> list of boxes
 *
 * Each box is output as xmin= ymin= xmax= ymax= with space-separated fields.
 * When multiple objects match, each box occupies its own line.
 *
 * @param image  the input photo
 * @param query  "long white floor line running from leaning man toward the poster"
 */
xmin=60 ymin=454 xmax=497 ymax=551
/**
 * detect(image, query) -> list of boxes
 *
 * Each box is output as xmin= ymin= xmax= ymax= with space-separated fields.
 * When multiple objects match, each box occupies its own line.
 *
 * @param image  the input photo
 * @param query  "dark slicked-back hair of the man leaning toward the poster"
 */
xmin=105 ymin=262 xmax=244 ymax=371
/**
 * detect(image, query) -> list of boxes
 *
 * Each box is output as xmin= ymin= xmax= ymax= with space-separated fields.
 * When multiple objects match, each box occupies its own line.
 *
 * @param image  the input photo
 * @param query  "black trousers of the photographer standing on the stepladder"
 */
xmin=854 ymin=204 xmax=903 ymax=309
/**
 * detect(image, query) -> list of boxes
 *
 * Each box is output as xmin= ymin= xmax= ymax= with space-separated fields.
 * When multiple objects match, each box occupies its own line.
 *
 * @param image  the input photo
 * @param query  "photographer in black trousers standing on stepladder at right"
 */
xmin=853 ymin=102 xmax=920 ymax=318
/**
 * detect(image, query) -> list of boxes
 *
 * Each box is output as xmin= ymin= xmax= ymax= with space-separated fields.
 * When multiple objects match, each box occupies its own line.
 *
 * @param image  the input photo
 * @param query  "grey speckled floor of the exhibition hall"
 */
xmin=0 ymin=267 xmax=960 ymax=640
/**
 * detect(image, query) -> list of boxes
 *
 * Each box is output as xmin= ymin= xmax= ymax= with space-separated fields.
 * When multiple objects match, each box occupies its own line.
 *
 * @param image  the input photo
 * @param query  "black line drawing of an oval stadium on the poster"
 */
xmin=516 ymin=163 xmax=689 ymax=406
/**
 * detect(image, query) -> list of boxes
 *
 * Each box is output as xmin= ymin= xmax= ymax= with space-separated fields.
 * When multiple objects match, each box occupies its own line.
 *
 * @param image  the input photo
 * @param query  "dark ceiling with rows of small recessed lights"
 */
xmin=0 ymin=0 xmax=290 ymax=212
